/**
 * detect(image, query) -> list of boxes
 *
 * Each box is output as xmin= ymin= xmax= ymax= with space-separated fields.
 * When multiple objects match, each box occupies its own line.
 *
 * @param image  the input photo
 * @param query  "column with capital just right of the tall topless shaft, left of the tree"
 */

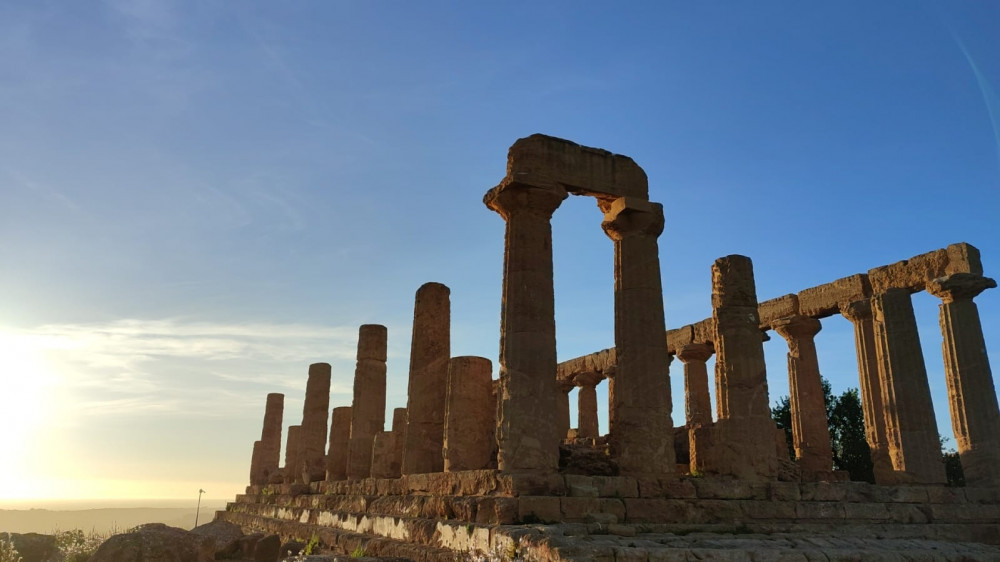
xmin=771 ymin=315 xmax=833 ymax=478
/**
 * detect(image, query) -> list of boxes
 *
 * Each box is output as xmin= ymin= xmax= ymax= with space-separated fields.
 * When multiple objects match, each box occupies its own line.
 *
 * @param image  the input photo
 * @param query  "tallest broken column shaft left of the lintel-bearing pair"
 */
xmin=402 ymin=283 xmax=451 ymax=474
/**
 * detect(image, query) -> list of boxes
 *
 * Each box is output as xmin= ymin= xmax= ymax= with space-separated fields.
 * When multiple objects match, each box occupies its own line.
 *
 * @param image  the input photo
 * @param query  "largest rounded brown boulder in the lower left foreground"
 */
xmin=90 ymin=523 xmax=215 ymax=562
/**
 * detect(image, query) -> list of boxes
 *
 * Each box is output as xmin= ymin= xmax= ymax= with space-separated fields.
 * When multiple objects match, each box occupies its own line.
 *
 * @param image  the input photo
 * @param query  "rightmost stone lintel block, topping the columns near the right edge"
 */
xmin=868 ymin=242 xmax=983 ymax=293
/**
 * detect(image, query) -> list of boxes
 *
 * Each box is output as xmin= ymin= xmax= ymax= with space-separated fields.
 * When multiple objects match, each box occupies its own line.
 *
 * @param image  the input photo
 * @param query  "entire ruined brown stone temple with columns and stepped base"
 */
xmin=217 ymin=135 xmax=1000 ymax=561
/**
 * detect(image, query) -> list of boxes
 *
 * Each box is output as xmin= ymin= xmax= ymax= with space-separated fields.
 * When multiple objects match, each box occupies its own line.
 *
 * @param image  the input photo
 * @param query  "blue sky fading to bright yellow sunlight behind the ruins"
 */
xmin=0 ymin=0 xmax=1000 ymax=498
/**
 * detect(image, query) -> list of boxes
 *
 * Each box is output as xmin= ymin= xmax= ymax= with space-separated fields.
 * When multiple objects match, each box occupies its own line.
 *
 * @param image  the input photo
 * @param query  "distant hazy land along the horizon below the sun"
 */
xmin=0 ymin=500 xmax=226 ymax=534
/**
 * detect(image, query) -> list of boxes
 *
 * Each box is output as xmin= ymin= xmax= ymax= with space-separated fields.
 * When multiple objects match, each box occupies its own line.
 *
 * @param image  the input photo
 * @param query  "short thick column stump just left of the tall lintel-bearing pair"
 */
xmin=443 ymin=357 xmax=495 ymax=472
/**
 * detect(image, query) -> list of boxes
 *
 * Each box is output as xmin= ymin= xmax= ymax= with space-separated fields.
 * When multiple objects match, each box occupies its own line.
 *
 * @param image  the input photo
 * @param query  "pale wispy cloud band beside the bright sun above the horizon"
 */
xmin=0 ymin=318 xmax=370 ymax=416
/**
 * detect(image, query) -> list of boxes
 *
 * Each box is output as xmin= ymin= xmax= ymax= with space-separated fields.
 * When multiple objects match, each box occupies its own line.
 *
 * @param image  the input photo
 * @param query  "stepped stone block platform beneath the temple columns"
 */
xmin=217 ymin=470 xmax=1000 ymax=561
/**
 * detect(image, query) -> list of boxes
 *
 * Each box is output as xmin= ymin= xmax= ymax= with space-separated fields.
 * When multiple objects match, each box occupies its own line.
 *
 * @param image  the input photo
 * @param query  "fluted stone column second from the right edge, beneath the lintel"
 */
xmin=872 ymin=289 xmax=945 ymax=484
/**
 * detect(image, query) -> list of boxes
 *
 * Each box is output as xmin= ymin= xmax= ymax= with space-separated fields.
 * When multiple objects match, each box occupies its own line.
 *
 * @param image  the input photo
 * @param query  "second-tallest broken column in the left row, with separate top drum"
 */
xmin=347 ymin=324 xmax=387 ymax=480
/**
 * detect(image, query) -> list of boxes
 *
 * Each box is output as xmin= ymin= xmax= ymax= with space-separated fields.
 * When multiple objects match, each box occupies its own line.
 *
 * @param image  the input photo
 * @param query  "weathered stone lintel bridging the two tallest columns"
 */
xmin=493 ymin=134 xmax=649 ymax=200
